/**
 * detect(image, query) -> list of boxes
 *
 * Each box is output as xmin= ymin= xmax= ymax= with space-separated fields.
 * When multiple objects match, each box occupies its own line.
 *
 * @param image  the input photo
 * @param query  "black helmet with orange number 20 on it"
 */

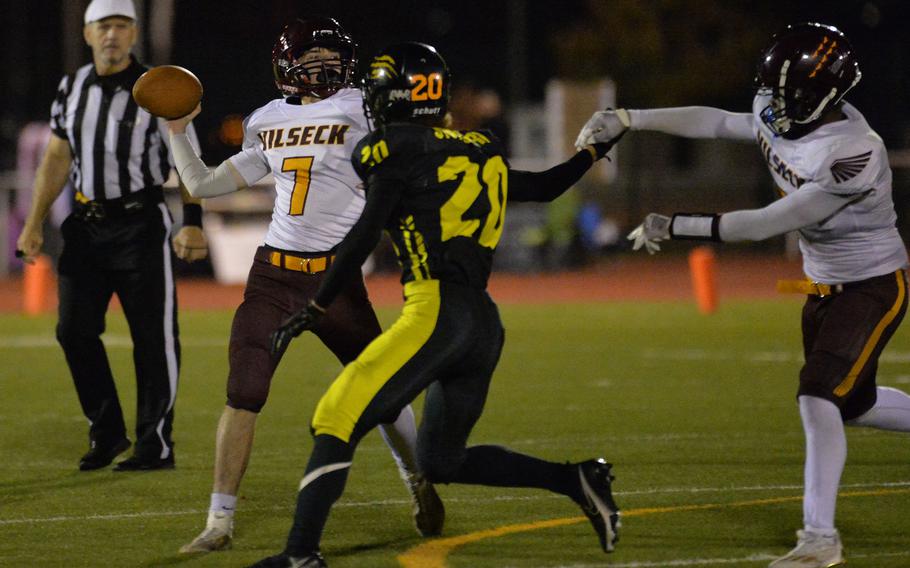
xmin=361 ymin=42 xmax=450 ymax=127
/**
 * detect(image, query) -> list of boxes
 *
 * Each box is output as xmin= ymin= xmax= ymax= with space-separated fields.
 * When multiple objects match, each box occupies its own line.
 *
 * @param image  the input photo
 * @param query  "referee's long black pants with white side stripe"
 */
xmin=57 ymin=203 xmax=180 ymax=459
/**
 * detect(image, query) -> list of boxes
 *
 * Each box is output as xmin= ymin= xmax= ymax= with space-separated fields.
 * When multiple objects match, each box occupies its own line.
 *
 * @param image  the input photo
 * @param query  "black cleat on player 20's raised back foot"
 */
xmin=578 ymin=458 xmax=620 ymax=552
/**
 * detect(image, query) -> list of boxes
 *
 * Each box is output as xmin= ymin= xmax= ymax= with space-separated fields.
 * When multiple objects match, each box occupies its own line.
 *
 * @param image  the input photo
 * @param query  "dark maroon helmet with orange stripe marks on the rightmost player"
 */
xmin=755 ymin=23 xmax=862 ymax=138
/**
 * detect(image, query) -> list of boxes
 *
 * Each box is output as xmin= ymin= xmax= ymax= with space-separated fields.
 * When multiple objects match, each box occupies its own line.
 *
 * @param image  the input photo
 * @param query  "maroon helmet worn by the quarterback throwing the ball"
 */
xmin=272 ymin=17 xmax=357 ymax=99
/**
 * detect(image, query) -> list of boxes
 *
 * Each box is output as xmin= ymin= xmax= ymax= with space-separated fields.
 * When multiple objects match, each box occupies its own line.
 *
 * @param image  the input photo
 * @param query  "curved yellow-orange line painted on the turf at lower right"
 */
xmin=398 ymin=488 xmax=910 ymax=568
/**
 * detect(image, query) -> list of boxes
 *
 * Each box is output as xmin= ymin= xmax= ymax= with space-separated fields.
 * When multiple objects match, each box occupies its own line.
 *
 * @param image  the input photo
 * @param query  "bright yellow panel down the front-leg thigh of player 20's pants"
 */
xmin=313 ymin=280 xmax=439 ymax=442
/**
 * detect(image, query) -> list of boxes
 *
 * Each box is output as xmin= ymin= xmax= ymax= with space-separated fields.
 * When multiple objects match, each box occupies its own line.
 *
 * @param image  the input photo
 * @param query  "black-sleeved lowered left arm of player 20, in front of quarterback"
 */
xmin=313 ymin=177 xmax=404 ymax=308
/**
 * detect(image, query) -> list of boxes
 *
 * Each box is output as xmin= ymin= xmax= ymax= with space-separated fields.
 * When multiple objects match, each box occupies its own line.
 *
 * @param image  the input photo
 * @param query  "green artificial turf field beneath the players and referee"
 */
xmin=0 ymin=300 xmax=910 ymax=568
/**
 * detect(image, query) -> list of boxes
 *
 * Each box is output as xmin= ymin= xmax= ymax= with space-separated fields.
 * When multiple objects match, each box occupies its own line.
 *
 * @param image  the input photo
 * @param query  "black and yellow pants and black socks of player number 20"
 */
xmin=286 ymin=280 xmax=581 ymax=556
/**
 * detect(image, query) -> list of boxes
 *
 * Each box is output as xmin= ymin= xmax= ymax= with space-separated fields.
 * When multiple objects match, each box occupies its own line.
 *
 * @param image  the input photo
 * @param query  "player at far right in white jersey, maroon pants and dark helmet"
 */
xmin=576 ymin=23 xmax=910 ymax=568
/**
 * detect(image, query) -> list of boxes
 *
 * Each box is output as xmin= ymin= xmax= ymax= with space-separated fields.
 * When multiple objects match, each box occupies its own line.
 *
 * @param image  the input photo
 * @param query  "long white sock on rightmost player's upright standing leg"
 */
xmin=799 ymin=396 xmax=847 ymax=534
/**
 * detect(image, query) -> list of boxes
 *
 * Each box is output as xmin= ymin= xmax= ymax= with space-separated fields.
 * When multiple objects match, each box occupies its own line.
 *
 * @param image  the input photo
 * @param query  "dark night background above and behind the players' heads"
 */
xmin=0 ymin=0 xmax=910 ymax=169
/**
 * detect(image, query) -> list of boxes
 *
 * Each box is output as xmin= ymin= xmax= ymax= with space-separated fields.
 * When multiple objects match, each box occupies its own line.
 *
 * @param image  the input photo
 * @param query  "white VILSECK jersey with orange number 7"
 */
xmin=230 ymin=89 xmax=369 ymax=252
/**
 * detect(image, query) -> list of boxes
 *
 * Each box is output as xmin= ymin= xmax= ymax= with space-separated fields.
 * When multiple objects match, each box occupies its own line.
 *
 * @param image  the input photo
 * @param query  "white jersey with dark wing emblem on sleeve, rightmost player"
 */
xmin=752 ymin=96 xmax=907 ymax=284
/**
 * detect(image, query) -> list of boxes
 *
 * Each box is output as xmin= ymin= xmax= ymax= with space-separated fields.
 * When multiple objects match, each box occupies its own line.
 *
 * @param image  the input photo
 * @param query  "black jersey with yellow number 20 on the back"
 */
xmin=351 ymin=124 xmax=509 ymax=289
